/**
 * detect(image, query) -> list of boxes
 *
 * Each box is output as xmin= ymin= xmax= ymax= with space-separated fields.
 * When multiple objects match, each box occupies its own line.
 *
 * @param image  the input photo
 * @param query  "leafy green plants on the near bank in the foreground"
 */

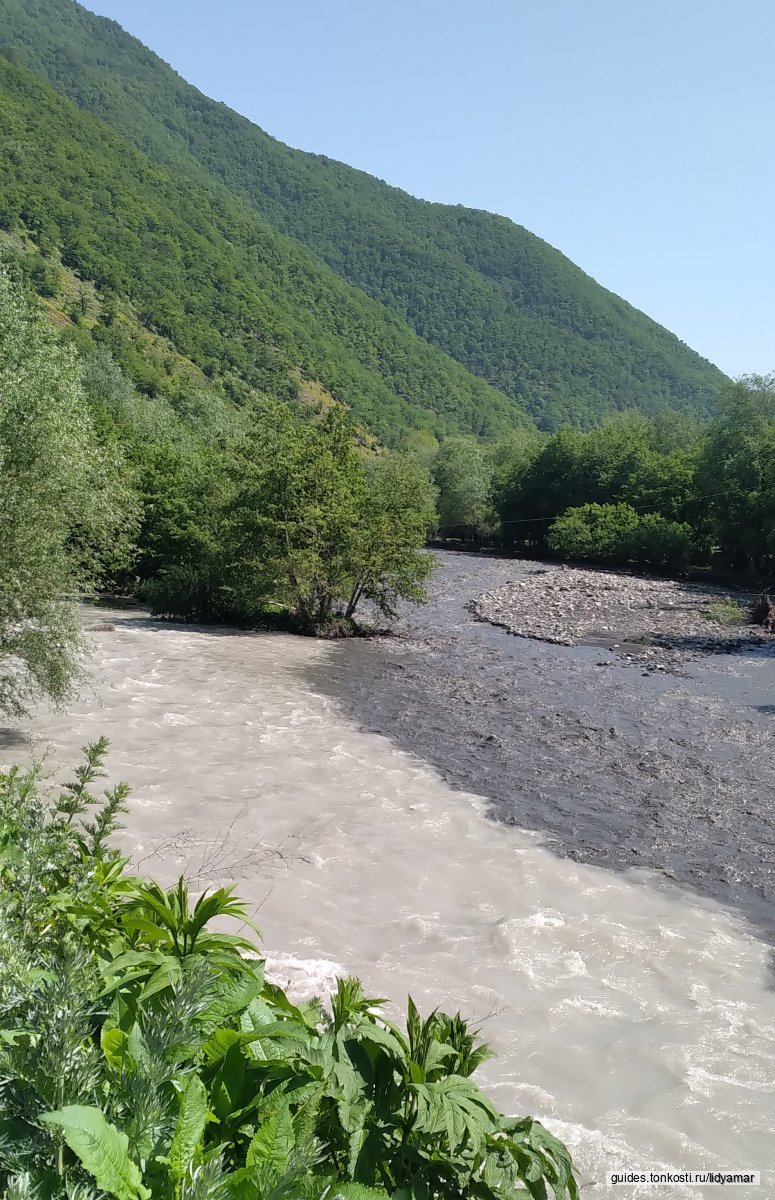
xmin=0 ymin=740 xmax=578 ymax=1200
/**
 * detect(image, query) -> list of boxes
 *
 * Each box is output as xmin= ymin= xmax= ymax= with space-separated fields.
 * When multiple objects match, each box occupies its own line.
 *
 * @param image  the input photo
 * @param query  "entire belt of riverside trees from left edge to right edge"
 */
xmin=0 ymin=260 xmax=775 ymax=713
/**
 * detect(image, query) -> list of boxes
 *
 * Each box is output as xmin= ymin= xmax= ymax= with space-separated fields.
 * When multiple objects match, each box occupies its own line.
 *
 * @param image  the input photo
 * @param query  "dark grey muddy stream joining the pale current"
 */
xmin=310 ymin=553 xmax=775 ymax=942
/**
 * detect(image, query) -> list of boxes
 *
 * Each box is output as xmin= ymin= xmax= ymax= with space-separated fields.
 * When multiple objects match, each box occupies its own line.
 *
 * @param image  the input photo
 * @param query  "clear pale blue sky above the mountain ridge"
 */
xmin=82 ymin=0 xmax=775 ymax=374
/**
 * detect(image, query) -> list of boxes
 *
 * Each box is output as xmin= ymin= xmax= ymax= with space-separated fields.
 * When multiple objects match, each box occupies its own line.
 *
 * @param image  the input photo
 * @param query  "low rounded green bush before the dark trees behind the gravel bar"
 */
xmin=547 ymin=504 xmax=692 ymax=570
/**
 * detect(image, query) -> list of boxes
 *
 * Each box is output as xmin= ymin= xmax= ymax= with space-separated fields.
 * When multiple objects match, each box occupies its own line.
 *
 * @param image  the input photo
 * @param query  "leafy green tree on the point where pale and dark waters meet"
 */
xmin=227 ymin=407 xmax=433 ymax=631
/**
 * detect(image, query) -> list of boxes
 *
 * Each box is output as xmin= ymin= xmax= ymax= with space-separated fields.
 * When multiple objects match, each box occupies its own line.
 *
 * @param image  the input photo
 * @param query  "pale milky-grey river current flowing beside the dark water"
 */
xmin=16 ymin=610 xmax=775 ymax=1200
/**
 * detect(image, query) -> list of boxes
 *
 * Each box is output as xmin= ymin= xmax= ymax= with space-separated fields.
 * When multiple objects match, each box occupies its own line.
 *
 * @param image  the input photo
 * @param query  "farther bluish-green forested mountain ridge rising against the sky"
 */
xmin=0 ymin=0 xmax=722 ymax=434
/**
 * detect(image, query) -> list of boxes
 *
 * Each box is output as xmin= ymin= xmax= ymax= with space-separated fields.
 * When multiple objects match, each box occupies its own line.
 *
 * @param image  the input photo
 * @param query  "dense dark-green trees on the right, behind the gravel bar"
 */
xmin=431 ymin=386 xmax=775 ymax=578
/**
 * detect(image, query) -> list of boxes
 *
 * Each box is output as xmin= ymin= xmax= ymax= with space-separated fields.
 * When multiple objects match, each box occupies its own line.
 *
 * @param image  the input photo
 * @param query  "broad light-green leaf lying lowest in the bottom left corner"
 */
xmin=40 ymin=1104 xmax=151 ymax=1200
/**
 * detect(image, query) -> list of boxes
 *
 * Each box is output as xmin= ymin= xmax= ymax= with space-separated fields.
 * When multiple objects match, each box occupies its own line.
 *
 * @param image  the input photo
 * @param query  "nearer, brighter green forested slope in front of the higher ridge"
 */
xmin=0 ymin=56 xmax=528 ymax=440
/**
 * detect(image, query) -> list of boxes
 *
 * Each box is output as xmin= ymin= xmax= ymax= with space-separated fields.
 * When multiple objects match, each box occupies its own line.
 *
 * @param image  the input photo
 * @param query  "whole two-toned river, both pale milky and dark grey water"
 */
xmin=12 ymin=556 xmax=775 ymax=1200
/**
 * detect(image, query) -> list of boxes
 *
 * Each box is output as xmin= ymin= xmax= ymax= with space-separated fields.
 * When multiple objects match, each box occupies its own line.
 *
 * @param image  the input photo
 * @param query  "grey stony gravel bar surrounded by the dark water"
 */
xmin=470 ymin=564 xmax=775 ymax=671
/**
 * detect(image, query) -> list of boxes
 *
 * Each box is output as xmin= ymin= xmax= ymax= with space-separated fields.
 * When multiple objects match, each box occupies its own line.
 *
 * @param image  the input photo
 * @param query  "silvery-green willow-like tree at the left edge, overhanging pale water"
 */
xmin=0 ymin=270 xmax=136 ymax=715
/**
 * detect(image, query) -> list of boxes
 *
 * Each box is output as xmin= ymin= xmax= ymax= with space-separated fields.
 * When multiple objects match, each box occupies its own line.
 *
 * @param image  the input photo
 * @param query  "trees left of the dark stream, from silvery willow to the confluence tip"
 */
xmin=0 ymin=272 xmax=434 ymax=714
